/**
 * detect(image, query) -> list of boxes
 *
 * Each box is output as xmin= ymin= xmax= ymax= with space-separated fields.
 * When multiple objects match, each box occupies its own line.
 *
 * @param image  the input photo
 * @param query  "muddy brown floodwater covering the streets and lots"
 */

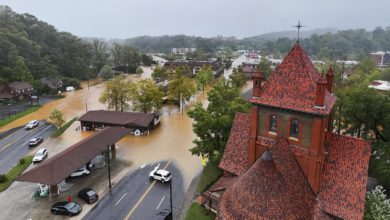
xmin=0 ymin=75 xmax=207 ymax=189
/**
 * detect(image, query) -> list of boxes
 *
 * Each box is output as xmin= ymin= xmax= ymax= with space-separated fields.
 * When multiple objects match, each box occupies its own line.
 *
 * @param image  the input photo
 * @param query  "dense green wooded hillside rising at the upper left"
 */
xmin=0 ymin=6 xmax=152 ymax=84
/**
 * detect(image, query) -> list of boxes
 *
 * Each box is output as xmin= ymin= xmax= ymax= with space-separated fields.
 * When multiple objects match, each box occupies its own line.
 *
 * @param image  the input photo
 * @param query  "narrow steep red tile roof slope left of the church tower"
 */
xmin=219 ymin=112 xmax=250 ymax=176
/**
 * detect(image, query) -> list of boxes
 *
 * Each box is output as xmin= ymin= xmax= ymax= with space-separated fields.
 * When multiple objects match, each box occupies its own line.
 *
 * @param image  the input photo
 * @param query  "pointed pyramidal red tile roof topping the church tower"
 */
xmin=249 ymin=43 xmax=335 ymax=115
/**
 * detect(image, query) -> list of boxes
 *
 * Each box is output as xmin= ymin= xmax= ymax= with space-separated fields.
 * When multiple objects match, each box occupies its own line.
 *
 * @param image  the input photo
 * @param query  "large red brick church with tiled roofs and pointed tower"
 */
xmin=198 ymin=42 xmax=370 ymax=219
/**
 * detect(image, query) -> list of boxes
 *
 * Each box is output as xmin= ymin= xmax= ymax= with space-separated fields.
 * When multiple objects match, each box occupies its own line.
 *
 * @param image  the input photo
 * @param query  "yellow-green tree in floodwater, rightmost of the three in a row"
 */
xmin=168 ymin=70 xmax=196 ymax=113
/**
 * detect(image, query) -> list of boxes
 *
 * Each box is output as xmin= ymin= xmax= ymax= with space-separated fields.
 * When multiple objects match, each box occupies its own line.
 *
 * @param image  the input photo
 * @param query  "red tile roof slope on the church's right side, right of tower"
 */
xmin=319 ymin=133 xmax=370 ymax=219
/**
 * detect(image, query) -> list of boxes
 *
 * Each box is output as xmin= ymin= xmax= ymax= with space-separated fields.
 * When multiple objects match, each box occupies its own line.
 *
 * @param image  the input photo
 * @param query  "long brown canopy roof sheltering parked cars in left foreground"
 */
xmin=15 ymin=127 xmax=129 ymax=185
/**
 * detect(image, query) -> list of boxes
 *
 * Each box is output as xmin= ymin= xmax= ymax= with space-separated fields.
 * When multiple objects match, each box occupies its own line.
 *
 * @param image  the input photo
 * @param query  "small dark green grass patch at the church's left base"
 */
xmin=197 ymin=162 xmax=222 ymax=193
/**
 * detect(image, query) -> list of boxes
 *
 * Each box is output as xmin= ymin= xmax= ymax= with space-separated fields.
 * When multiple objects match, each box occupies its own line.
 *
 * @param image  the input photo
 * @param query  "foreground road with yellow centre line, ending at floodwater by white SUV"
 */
xmin=83 ymin=161 xmax=184 ymax=220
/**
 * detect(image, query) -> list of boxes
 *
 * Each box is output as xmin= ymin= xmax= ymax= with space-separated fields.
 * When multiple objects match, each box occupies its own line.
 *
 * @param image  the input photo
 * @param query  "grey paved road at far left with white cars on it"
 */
xmin=0 ymin=121 xmax=55 ymax=174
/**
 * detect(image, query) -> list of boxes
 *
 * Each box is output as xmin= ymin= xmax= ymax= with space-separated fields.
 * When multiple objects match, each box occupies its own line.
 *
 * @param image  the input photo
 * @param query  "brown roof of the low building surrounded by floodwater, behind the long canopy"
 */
xmin=78 ymin=110 xmax=154 ymax=127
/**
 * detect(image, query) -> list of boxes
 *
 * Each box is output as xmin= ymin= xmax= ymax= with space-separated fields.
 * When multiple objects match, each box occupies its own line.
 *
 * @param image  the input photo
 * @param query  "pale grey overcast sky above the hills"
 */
xmin=0 ymin=0 xmax=390 ymax=38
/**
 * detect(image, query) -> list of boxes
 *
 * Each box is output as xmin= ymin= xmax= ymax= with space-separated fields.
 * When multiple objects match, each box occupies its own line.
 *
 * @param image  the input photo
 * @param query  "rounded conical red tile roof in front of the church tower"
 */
xmin=218 ymin=140 xmax=322 ymax=219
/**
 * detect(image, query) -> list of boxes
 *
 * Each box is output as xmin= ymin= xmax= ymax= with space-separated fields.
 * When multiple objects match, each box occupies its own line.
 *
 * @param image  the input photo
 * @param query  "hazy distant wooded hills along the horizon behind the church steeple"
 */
xmin=124 ymin=27 xmax=390 ymax=60
